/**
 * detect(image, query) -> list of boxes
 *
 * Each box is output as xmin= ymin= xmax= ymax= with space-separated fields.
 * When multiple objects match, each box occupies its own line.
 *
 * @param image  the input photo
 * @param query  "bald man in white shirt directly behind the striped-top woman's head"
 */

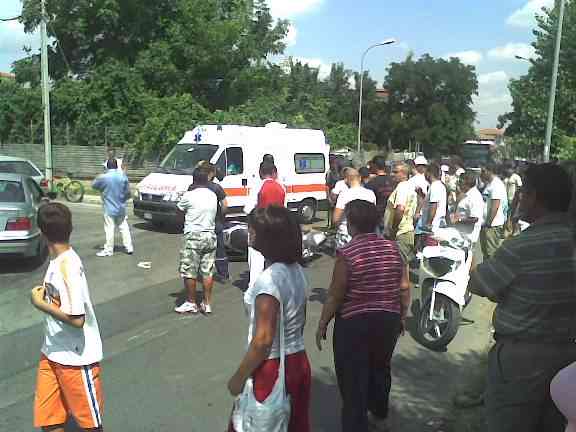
xmin=332 ymin=168 xmax=376 ymax=248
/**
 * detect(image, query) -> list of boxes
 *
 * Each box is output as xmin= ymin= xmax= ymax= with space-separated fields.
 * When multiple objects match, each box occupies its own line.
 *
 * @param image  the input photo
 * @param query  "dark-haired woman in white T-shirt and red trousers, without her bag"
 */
xmin=228 ymin=206 xmax=311 ymax=432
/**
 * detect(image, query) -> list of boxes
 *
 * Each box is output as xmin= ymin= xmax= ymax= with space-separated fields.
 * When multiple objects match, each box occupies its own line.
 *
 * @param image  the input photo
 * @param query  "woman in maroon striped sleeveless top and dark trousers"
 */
xmin=316 ymin=200 xmax=410 ymax=432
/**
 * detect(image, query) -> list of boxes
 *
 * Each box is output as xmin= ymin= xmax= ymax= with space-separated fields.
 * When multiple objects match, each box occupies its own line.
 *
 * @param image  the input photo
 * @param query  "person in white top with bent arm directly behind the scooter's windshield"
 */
xmin=452 ymin=174 xmax=484 ymax=245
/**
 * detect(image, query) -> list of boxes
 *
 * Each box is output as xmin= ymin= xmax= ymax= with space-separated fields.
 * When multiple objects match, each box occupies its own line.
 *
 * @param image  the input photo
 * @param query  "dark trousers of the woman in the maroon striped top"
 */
xmin=334 ymin=312 xmax=401 ymax=432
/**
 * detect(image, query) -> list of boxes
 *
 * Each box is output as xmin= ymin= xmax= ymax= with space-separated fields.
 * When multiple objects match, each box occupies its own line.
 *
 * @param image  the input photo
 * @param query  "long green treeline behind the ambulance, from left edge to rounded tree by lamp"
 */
xmin=0 ymin=0 xmax=477 ymax=158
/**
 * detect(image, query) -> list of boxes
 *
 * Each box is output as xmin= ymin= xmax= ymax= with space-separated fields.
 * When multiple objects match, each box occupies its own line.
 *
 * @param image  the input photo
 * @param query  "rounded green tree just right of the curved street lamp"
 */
xmin=385 ymin=54 xmax=478 ymax=155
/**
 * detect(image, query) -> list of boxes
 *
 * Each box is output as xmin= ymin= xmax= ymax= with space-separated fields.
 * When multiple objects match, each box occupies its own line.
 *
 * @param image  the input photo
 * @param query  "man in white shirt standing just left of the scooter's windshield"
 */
xmin=416 ymin=164 xmax=448 ymax=244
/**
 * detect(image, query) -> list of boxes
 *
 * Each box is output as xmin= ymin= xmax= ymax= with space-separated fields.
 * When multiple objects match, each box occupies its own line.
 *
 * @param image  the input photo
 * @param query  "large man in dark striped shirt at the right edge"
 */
xmin=470 ymin=164 xmax=576 ymax=432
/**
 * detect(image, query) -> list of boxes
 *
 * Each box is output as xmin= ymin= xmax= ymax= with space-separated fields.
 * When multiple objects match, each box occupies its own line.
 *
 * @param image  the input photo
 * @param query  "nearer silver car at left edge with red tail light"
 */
xmin=0 ymin=173 xmax=48 ymax=263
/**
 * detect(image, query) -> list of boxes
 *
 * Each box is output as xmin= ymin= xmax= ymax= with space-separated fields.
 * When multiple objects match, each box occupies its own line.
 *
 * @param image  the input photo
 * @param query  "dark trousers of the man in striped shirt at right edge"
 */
xmin=485 ymin=340 xmax=576 ymax=432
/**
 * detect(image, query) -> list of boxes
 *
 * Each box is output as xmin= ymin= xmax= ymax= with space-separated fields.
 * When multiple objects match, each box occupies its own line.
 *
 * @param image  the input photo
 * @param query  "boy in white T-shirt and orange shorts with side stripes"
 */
xmin=31 ymin=203 xmax=104 ymax=432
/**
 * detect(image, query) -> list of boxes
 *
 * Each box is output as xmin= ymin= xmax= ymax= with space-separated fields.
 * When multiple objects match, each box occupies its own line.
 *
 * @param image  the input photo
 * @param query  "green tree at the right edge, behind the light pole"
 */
xmin=500 ymin=0 xmax=576 ymax=154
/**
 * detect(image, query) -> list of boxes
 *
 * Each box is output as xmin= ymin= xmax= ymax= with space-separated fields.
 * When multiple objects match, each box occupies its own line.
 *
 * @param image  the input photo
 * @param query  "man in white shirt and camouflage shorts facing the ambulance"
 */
xmin=174 ymin=167 xmax=218 ymax=314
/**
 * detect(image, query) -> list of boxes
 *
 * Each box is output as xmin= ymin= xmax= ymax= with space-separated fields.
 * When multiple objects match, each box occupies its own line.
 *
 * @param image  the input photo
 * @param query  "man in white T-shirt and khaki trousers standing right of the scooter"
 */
xmin=480 ymin=164 xmax=508 ymax=259
